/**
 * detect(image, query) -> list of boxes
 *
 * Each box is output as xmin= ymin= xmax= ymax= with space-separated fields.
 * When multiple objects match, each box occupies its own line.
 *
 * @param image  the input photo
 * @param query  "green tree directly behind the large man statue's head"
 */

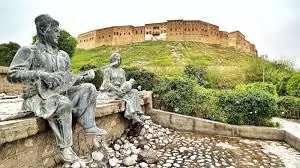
xmin=32 ymin=29 xmax=77 ymax=57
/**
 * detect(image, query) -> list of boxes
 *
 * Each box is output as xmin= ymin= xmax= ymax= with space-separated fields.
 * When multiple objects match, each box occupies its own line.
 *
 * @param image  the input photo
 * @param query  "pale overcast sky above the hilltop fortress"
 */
xmin=0 ymin=0 xmax=300 ymax=68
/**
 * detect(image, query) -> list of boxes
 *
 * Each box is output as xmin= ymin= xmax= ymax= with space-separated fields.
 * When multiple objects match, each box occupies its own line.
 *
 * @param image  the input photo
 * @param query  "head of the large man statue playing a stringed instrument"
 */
xmin=34 ymin=14 xmax=60 ymax=46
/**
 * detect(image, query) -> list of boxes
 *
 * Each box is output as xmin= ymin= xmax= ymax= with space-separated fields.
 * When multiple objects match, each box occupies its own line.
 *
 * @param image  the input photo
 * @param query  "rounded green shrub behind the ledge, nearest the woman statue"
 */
xmin=153 ymin=79 xmax=199 ymax=116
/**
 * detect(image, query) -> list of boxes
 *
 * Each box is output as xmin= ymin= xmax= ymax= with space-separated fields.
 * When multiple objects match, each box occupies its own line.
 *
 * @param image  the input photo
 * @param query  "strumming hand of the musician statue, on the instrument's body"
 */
xmin=40 ymin=72 xmax=62 ymax=89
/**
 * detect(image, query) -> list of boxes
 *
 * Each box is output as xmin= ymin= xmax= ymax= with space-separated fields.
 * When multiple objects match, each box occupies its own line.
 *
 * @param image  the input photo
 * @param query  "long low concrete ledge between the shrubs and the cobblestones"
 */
xmin=150 ymin=109 xmax=284 ymax=140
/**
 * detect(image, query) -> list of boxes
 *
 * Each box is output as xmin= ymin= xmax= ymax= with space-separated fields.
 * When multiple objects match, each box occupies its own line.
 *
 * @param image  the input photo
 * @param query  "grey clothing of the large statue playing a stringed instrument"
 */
xmin=8 ymin=42 xmax=97 ymax=148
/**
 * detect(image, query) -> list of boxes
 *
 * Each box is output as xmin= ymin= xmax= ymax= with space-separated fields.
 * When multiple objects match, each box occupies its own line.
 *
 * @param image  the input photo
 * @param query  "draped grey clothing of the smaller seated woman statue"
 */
xmin=98 ymin=67 xmax=143 ymax=119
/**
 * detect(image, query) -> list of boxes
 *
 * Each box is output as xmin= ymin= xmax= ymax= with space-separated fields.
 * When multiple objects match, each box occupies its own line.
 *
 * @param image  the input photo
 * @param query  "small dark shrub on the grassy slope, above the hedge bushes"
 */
xmin=184 ymin=65 xmax=209 ymax=86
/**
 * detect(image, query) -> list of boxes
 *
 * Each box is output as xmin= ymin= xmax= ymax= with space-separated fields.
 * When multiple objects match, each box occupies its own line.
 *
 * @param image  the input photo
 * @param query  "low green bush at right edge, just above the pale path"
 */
xmin=277 ymin=96 xmax=300 ymax=118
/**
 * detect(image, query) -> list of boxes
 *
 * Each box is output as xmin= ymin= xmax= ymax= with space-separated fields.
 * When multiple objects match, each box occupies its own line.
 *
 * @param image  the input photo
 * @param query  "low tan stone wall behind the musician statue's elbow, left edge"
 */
xmin=0 ymin=66 xmax=23 ymax=95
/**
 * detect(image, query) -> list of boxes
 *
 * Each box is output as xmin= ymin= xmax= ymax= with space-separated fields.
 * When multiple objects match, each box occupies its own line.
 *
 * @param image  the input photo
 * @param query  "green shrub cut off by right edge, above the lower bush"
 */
xmin=287 ymin=73 xmax=300 ymax=97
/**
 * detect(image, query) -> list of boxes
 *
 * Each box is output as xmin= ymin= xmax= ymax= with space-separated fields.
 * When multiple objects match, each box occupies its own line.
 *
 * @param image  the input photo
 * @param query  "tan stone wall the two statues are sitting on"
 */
xmin=0 ymin=91 xmax=152 ymax=168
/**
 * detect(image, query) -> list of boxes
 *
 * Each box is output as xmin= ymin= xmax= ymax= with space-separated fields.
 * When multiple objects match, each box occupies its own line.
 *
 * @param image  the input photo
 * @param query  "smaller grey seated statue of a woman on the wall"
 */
xmin=98 ymin=53 xmax=150 ymax=124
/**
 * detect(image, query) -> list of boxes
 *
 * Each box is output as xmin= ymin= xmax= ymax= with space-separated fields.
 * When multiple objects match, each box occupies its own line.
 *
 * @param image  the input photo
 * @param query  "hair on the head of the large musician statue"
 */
xmin=34 ymin=14 xmax=59 ymax=38
